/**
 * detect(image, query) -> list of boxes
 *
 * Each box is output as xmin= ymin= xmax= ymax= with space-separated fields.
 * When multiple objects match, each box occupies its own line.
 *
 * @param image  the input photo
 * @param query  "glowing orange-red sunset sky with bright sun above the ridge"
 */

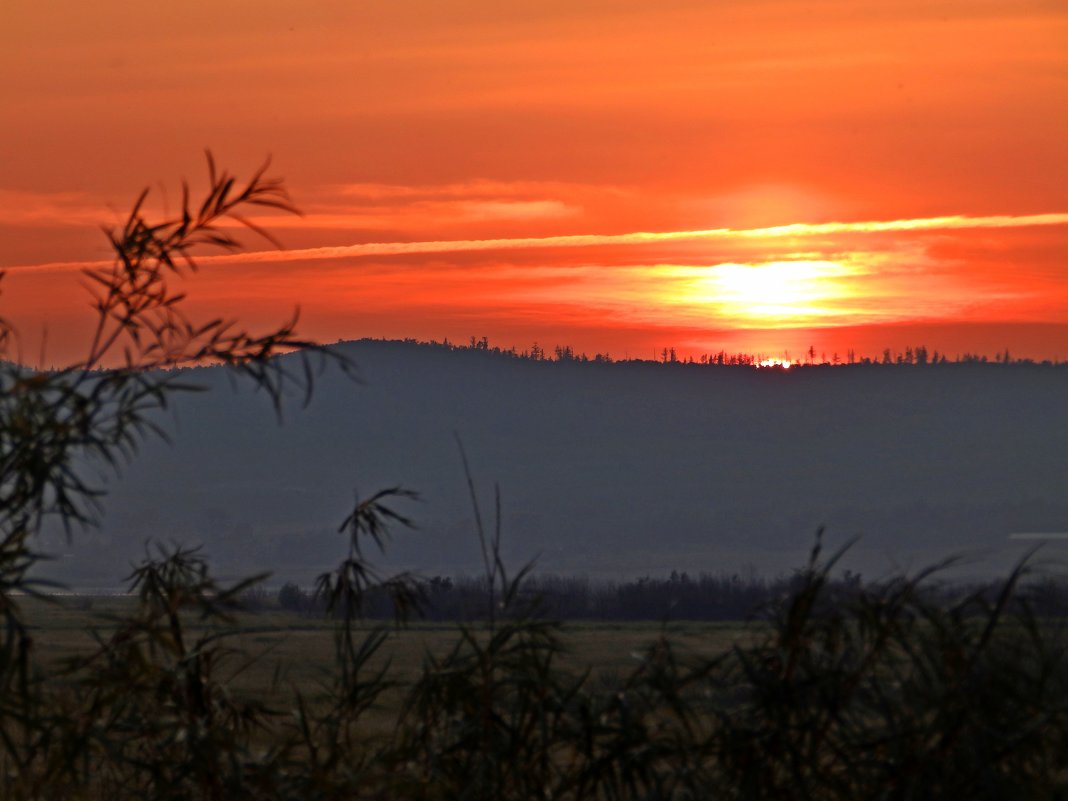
xmin=0 ymin=0 xmax=1068 ymax=362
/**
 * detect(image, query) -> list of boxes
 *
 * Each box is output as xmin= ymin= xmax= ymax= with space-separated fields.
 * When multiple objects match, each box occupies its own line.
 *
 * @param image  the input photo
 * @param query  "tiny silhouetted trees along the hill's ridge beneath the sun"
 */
xmin=382 ymin=336 xmax=1064 ymax=368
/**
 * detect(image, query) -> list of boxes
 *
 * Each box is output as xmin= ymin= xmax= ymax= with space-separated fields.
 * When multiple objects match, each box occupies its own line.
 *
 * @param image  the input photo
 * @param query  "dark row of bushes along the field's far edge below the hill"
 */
xmin=269 ymin=570 xmax=1068 ymax=622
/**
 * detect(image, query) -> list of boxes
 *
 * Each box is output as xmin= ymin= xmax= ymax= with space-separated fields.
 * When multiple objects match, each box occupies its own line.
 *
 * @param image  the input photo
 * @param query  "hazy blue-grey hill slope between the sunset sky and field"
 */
xmin=43 ymin=341 xmax=1068 ymax=583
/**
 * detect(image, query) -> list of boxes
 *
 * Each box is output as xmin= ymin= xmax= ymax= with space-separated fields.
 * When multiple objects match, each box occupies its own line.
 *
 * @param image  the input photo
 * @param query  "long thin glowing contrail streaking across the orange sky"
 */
xmin=4 ymin=211 xmax=1068 ymax=270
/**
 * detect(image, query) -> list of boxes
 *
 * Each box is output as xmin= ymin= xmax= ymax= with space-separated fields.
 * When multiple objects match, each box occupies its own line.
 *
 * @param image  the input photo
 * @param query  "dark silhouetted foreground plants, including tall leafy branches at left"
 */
xmin=0 ymin=160 xmax=1068 ymax=800
